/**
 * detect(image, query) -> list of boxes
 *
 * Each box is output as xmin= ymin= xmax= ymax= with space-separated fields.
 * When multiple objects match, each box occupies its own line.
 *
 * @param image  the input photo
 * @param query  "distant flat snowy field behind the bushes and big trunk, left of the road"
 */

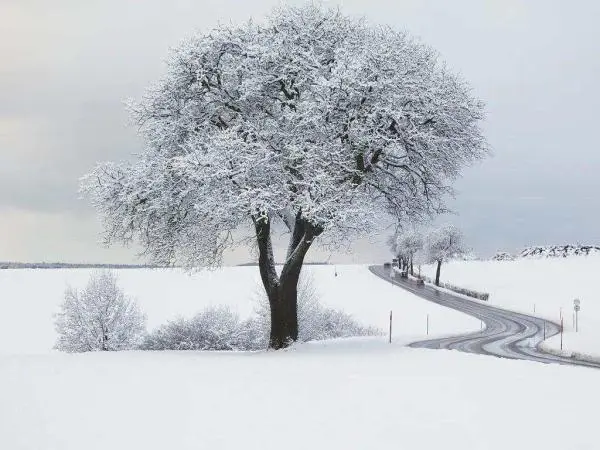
xmin=0 ymin=265 xmax=480 ymax=354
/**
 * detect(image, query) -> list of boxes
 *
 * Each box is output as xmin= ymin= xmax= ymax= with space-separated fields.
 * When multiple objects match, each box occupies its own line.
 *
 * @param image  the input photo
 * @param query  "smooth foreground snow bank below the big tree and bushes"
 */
xmin=0 ymin=340 xmax=600 ymax=450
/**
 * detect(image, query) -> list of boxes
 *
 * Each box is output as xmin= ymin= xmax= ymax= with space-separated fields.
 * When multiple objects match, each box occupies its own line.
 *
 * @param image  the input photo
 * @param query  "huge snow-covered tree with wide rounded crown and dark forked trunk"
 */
xmin=83 ymin=4 xmax=487 ymax=348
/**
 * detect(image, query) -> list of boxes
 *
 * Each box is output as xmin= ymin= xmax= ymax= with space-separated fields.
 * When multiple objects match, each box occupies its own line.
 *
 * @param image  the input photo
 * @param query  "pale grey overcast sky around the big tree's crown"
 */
xmin=0 ymin=0 xmax=600 ymax=263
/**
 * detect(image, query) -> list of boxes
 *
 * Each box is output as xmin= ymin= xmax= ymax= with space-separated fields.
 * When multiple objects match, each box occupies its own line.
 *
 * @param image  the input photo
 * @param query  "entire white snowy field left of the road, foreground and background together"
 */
xmin=0 ymin=266 xmax=600 ymax=450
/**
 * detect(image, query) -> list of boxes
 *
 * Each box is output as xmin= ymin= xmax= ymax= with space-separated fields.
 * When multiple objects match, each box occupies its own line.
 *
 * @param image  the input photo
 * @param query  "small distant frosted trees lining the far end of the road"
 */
xmin=388 ymin=225 xmax=467 ymax=286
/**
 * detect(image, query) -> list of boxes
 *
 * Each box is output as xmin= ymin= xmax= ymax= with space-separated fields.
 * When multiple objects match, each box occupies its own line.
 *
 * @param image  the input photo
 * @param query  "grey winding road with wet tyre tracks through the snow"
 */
xmin=369 ymin=266 xmax=600 ymax=369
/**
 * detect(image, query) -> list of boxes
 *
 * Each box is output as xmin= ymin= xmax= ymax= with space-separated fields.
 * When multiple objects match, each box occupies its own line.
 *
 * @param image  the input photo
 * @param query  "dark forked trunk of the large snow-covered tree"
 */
xmin=254 ymin=214 xmax=322 ymax=349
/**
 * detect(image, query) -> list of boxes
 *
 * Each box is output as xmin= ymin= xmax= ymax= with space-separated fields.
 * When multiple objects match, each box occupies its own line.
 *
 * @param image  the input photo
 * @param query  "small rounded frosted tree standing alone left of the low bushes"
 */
xmin=55 ymin=271 xmax=146 ymax=353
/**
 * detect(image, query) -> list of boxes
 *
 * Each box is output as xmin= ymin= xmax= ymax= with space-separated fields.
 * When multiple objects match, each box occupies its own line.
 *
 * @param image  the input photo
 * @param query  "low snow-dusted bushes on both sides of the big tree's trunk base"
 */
xmin=141 ymin=277 xmax=381 ymax=350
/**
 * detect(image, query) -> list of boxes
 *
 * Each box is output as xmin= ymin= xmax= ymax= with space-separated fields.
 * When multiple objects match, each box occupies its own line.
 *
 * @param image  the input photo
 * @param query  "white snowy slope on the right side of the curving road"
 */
xmin=422 ymin=255 xmax=600 ymax=357
